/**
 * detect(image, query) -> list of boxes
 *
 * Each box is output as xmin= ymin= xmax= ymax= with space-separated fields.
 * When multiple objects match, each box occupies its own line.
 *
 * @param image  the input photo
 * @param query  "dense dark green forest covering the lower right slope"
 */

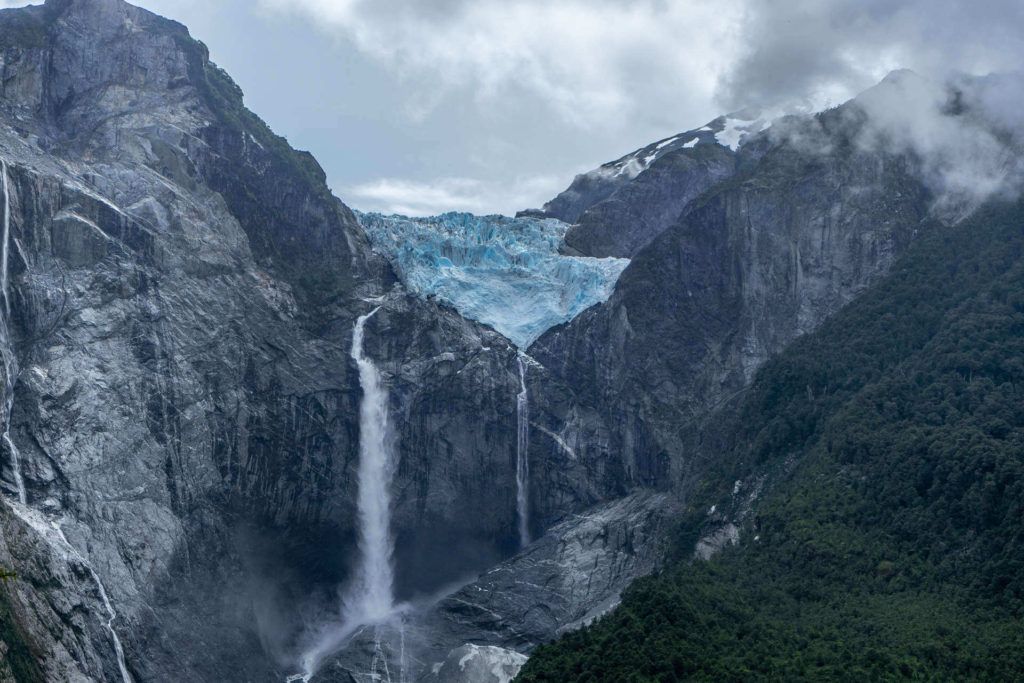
xmin=519 ymin=200 xmax=1024 ymax=683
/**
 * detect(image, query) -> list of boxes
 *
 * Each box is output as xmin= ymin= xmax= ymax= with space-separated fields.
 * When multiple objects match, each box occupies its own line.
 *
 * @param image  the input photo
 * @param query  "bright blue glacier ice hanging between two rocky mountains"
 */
xmin=359 ymin=213 xmax=629 ymax=348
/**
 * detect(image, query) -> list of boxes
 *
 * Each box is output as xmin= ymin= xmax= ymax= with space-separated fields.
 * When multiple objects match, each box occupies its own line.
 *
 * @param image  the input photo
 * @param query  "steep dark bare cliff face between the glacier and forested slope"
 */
xmin=530 ymin=103 xmax=930 ymax=487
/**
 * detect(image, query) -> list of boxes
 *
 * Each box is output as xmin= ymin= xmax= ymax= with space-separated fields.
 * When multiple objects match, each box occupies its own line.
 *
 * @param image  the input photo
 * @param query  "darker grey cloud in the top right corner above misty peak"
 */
xmin=718 ymin=0 xmax=1024 ymax=109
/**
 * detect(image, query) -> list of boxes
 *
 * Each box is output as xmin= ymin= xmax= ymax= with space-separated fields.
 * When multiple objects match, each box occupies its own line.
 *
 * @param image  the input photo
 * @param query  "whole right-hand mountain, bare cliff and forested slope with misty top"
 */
xmin=517 ymin=72 xmax=1024 ymax=681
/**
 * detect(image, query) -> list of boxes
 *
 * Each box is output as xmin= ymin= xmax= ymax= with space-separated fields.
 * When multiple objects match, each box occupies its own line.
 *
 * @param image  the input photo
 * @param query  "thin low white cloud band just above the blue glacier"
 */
xmin=342 ymin=176 xmax=564 ymax=216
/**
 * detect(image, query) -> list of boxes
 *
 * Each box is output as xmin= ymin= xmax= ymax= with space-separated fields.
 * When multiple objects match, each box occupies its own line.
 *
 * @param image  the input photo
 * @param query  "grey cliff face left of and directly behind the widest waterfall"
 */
xmin=0 ymin=0 xmax=606 ymax=680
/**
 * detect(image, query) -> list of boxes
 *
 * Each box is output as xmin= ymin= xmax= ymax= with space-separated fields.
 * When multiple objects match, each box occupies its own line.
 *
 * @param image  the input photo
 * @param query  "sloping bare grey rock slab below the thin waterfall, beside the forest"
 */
xmin=303 ymin=492 xmax=680 ymax=683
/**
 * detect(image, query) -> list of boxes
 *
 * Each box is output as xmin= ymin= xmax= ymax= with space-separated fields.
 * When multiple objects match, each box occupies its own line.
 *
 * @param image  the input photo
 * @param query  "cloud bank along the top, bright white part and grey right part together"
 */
xmin=259 ymin=0 xmax=1024 ymax=128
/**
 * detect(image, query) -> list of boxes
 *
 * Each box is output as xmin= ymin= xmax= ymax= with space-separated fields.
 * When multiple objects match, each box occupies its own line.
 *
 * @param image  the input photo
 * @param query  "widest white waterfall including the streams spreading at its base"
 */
xmin=287 ymin=306 xmax=397 ymax=681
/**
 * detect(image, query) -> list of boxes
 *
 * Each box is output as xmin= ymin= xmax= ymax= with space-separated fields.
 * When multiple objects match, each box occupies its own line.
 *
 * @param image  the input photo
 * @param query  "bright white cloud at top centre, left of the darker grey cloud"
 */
xmin=251 ymin=0 xmax=742 ymax=129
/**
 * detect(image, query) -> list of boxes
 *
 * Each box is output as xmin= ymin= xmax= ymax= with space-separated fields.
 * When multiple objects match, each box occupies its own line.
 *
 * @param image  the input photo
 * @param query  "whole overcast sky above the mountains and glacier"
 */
xmin=6 ymin=0 xmax=1024 ymax=214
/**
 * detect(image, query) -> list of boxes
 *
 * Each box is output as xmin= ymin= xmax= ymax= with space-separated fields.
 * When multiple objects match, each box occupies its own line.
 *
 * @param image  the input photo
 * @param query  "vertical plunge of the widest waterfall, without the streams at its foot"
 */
xmin=345 ymin=306 xmax=394 ymax=624
